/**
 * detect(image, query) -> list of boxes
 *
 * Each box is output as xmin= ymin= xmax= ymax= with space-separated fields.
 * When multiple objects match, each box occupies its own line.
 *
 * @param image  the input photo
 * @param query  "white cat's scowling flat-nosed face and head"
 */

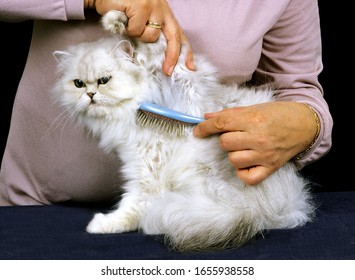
xmin=55 ymin=38 xmax=141 ymax=117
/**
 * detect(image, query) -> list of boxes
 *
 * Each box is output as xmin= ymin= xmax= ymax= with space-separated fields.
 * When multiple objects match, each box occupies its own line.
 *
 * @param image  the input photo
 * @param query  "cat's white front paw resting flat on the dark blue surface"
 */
xmin=86 ymin=213 xmax=137 ymax=233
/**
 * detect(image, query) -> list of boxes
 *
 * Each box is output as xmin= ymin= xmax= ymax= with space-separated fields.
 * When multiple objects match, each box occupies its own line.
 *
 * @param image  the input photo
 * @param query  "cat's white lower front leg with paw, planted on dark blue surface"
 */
xmin=86 ymin=194 xmax=141 ymax=233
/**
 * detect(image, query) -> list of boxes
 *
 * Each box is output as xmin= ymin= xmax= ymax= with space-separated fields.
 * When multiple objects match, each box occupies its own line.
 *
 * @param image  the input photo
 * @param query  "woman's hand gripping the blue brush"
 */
xmin=194 ymin=102 xmax=317 ymax=185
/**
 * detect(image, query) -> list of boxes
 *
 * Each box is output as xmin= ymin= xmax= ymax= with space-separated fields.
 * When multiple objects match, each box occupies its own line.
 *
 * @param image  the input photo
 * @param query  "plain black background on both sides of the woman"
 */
xmin=0 ymin=1 xmax=355 ymax=192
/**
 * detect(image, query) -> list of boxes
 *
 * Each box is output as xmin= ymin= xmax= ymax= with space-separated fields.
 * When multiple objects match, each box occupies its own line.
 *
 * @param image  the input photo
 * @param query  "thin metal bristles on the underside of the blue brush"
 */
xmin=137 ymin=110 xmax=191 ymax=137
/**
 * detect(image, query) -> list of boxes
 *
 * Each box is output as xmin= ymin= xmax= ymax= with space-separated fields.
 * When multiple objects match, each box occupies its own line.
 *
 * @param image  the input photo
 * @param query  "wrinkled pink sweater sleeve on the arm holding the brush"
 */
xmin=253 ymin=0 xmax=333 ymax=169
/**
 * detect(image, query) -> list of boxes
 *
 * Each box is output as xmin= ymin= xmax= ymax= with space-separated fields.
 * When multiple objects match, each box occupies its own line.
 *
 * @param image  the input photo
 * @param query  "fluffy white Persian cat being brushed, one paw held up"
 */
xmin=54 ymin=11 xmax=314 ymax=252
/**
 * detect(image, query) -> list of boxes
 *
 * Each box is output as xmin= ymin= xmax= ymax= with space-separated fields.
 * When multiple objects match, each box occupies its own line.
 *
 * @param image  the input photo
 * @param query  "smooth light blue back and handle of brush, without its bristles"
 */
xmin=139 ymin=102 xmax=205 ymax=124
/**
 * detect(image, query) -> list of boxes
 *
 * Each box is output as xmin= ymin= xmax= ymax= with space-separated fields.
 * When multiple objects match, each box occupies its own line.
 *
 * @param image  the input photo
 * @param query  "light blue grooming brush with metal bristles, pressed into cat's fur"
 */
xmin=137 ymin=102 xmax=205 ymax=136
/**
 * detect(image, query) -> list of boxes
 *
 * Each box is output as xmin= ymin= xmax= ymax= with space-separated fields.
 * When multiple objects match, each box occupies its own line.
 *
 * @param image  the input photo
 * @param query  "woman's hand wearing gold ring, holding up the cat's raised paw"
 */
xmin=84 ymin=0 xmax=195 ymax=75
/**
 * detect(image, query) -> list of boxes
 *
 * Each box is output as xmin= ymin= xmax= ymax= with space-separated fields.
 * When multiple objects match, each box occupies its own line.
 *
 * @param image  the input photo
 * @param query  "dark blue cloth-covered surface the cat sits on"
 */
xmin=0 ymin=192 xmax=355 ymax=260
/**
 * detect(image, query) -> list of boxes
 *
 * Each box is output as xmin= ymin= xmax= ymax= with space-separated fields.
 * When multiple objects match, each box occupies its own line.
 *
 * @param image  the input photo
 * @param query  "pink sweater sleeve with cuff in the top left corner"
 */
xmin=0 ymin=0 xmax=84 ymax=22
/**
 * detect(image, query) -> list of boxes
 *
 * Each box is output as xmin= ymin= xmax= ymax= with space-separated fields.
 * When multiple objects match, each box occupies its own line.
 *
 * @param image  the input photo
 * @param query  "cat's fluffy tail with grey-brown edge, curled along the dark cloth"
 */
xmin=142 ymin=194 xmax=261 ymax=252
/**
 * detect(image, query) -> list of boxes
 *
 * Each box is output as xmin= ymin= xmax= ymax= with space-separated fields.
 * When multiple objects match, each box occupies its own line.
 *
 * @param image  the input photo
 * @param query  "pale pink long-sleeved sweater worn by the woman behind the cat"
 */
xmin=0 ymin=0 xmax=333 ymax=205
